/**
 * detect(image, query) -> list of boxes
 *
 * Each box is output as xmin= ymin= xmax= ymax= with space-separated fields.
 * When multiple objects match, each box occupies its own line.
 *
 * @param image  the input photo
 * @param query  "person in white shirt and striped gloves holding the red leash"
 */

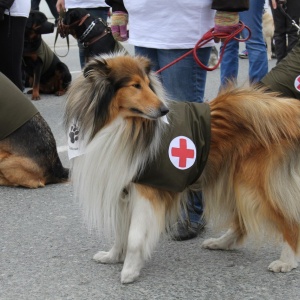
xmin=106 ymin=0 xmax=248 ymax=240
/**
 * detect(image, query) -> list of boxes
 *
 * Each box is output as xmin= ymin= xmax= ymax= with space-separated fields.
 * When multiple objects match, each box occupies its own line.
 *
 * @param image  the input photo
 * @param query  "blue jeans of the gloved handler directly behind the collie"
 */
xmin=135 ymin=46 xmax=211 ymax=224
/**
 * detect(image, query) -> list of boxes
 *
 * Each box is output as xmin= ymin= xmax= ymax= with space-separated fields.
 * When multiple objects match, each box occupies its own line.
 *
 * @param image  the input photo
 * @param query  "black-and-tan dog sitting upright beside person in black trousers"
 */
xmin=22 ymin=10 xmax=72 ymax=100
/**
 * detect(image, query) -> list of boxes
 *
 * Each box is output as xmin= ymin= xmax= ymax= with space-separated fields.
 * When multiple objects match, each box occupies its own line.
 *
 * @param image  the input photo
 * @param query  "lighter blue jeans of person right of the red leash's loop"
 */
xmin=221 ymin=0 xmax=268 ymax=86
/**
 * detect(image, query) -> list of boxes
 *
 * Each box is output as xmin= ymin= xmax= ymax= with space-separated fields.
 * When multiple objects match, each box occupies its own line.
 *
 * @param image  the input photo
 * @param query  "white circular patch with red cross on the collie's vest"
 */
xmin=169 ymin=136 xmax=196 ymax=170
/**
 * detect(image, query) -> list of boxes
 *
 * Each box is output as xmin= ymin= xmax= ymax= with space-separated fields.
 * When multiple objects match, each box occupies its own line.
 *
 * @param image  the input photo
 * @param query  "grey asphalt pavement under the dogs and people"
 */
xmin=0 ymin=28 xmax=300 ymax=300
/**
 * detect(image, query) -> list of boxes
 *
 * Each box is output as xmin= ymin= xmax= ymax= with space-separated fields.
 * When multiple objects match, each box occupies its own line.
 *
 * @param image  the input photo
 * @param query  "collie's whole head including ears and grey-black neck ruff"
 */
xmin=65 ymin=53 xmax=169 ymax=137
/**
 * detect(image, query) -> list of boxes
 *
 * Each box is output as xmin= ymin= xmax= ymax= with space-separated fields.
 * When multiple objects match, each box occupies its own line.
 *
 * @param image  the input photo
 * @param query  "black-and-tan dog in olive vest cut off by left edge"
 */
xmin=0 ymin=73 xmax=69 ymax=188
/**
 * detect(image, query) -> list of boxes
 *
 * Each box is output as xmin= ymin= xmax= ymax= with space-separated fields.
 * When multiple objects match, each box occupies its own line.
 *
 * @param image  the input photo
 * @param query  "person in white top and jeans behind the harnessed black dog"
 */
xmin=56 ymin=0 xmax=109 ymax=68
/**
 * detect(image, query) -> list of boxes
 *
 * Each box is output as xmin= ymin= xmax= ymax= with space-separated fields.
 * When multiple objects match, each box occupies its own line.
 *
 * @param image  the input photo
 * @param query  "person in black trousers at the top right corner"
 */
xmin=270 ymin=0 xmax=300 ymax=64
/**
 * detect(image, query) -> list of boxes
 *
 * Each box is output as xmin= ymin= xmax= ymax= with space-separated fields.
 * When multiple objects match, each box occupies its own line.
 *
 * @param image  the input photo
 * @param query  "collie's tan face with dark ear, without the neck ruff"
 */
xmin=84 ymin=56 xmax=169 ymax=120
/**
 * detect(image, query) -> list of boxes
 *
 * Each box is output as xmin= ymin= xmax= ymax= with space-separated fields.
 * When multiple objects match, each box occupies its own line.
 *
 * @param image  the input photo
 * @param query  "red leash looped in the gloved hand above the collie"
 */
xmin=155 ymin=21 xmax=251 ymax=74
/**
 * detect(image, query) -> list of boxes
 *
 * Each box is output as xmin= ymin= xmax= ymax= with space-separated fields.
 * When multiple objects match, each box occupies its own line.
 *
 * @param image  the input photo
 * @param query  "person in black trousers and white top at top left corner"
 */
xmin=0 ymin=0 xmax=30 ymax=91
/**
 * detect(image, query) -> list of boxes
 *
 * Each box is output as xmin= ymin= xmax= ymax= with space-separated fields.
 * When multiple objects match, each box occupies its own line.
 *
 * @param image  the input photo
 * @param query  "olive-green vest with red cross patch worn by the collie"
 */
xmin=134 ymin=102 xmax=210 ymax=192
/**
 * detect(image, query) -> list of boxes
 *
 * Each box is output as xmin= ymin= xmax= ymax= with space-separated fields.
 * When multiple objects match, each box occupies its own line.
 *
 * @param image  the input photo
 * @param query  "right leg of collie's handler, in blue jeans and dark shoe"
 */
xmin=158 ymin=47 xmax=211 ymax=240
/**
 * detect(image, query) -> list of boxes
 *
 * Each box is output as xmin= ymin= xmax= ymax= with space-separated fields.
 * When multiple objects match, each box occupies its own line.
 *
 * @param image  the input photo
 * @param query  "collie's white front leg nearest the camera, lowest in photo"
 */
xmin=121 ymin=189 xmax=164 ymax=283
